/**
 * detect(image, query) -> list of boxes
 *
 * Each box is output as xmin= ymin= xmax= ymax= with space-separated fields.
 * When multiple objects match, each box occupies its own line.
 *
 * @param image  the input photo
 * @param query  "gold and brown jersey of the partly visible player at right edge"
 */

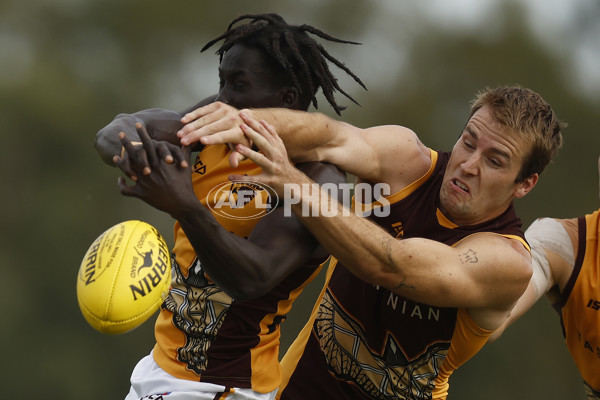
xmin=560 ymin=210 xmax=600 ymax=399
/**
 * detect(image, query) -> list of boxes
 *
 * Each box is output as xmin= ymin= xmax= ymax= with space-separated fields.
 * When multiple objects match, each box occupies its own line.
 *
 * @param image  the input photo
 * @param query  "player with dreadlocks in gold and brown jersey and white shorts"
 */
xmin=95 ymin=14 xmax=364 ymax=400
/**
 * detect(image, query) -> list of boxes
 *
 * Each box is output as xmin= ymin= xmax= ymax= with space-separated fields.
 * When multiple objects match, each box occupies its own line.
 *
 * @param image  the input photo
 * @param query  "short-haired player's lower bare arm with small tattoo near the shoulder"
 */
xmin=294 ymin=180 xmax=531 ymax=310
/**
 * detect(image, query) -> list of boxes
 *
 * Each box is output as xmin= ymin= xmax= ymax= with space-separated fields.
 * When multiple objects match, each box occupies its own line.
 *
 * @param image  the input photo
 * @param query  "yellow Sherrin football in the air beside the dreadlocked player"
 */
xmin=77 ymin=220 xmax=171 ymax=335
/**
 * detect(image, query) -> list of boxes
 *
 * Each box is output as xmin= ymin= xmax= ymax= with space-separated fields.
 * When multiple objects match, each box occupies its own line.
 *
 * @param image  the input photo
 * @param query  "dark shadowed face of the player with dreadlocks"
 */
xmin=217 ymin=44 xmax=292 ymax=109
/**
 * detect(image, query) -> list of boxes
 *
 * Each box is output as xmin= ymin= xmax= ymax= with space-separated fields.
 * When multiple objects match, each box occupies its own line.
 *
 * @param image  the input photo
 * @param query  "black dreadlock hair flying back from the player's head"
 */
xmin=201 ymin=14 xmax=366 ymax=115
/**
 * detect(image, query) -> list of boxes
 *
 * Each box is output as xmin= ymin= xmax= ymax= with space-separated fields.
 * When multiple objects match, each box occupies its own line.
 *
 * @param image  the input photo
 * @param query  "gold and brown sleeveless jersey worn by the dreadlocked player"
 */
xmin=153 ymin=145 xmax=322 ymax=393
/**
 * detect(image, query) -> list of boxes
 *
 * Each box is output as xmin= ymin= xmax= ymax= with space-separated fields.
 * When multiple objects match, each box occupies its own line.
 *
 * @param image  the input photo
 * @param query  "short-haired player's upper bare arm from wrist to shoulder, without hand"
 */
xmin=253 ymin=109 xmax=431 ymax=189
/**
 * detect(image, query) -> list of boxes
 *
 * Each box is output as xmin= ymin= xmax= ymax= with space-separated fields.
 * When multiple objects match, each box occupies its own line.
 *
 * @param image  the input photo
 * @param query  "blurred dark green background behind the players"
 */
xmin=0 ymin=0 xmax=600 ymax=399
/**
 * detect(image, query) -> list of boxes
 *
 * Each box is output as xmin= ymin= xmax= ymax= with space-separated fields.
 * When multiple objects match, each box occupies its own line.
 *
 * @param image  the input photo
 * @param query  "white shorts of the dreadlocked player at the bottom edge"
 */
xmin=125 ymin=353 xmax=277 ymax=400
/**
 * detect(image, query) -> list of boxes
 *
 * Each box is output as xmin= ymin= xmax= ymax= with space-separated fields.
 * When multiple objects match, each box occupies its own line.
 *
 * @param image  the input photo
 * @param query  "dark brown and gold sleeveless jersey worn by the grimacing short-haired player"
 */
xmin=278 ymin=150 xmax=529 ymax=400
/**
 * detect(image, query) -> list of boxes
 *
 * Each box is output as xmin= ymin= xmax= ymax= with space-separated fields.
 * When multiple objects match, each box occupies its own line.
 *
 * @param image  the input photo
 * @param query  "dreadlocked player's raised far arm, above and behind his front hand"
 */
xmin=94 ymin=95 xmax=216 ymax=166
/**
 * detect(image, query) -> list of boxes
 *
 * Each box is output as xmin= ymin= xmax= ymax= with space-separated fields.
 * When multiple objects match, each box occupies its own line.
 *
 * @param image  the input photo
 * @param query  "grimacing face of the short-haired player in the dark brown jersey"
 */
xmin=440 ymin=107 xmax=537 ymax=225
